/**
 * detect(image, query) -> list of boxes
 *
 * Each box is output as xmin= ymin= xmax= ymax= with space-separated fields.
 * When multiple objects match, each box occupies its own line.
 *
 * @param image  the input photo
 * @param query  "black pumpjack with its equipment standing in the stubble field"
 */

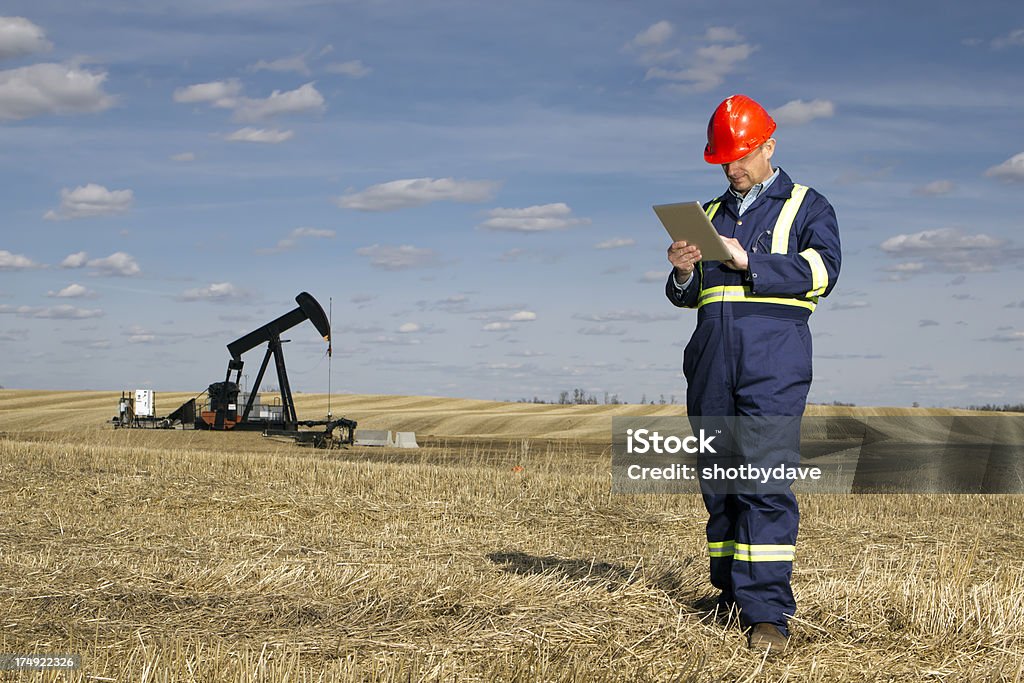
xmin=115 ymin=292 xmax=356 ymax=446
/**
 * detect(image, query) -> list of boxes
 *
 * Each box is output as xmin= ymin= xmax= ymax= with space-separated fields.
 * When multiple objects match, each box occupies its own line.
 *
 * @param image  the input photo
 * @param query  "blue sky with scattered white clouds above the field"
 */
xmin=0 ymin=0 xmax=1024 ymax=405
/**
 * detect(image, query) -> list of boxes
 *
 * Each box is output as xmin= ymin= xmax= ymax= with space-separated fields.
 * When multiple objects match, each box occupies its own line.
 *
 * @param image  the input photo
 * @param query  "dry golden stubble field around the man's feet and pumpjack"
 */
xmin=0 ymin=392 xmax=1024 ymax=682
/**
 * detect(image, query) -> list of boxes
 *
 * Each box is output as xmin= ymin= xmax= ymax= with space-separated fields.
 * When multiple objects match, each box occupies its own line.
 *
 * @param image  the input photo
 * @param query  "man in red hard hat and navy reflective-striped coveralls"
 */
xmin=666 ymin=94 xmax=841 ymax=653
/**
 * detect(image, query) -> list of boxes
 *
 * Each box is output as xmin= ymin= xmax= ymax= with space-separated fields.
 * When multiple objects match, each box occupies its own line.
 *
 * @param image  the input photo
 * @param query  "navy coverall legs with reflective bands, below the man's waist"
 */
xmin=683 ymin=314 xmax=811 ymax=635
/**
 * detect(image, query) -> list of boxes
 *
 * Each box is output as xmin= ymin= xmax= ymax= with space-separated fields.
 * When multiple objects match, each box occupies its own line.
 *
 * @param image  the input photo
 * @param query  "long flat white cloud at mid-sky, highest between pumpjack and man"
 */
xmin=335 ymin=178 xmax=501 ymax=211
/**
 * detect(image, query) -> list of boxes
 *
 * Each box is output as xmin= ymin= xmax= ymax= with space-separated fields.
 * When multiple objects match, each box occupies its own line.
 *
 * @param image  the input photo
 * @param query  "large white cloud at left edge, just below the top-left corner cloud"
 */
xmin=0 ymin=63 xmax=114 ymax=121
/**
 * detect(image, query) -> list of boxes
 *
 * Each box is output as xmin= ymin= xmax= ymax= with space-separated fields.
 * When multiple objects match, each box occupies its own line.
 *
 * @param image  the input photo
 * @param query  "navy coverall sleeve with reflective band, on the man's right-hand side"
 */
xmin=745 ymin=193 xmax=842 ymax=305
